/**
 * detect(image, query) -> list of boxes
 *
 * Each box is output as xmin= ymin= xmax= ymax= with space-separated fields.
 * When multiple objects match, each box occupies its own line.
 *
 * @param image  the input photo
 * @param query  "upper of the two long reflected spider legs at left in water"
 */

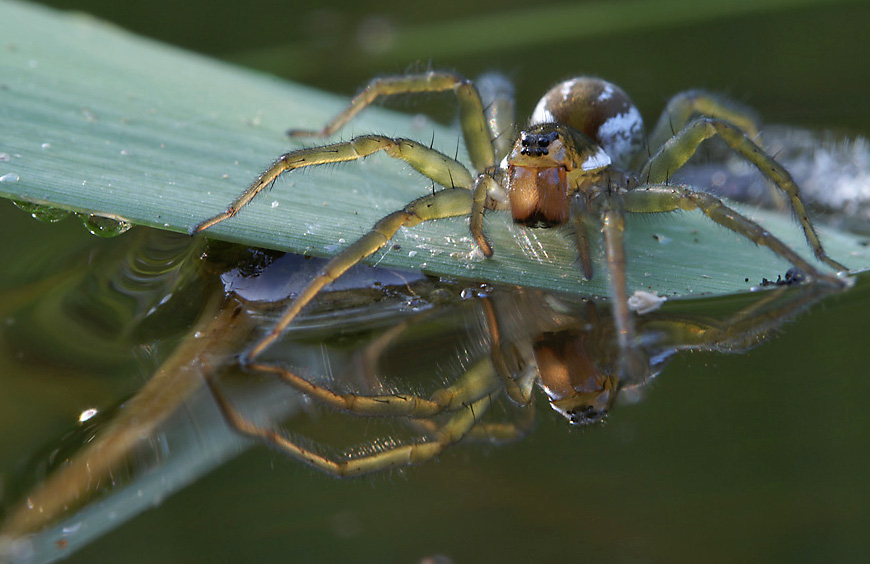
xmin=249 ymin=358 xmax=501 ymax=417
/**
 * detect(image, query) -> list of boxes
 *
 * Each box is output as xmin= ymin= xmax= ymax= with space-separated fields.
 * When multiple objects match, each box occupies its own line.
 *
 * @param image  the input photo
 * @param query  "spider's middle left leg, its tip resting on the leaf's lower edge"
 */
xmin=190 ymin=135 xmax=473 ymax=235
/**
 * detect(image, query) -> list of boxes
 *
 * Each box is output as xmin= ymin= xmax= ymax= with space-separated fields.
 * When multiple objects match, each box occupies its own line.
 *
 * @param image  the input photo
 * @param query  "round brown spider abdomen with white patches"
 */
xmin=531 ymin=76 xmax=643 ymax=168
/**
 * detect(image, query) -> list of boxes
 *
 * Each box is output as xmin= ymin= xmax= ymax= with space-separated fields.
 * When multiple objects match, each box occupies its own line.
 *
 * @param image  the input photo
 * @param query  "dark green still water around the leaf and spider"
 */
xmin=0 ymin=2 xmax=870 ymax=562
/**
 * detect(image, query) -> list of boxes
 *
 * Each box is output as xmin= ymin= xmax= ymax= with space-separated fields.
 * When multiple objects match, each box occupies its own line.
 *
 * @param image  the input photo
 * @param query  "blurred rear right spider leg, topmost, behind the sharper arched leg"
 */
xmin=632 ymin=90 xmax=759 ymax=169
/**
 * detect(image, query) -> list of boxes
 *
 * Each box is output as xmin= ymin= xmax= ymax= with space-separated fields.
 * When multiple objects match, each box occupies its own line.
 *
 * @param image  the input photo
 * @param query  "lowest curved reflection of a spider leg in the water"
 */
xmin=206 ymin=376 xmax=491 ymax=477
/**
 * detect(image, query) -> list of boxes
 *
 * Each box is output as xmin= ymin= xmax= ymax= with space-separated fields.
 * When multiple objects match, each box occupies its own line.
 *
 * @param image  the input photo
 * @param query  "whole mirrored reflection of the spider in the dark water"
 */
xmin=206 ymin=276 xmax=835 ymax=477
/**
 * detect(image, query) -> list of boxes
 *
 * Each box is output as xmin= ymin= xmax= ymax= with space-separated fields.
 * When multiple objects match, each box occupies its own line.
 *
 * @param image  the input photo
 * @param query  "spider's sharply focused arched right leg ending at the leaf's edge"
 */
xmin=639 ymin=118 xmax=849 ymax=271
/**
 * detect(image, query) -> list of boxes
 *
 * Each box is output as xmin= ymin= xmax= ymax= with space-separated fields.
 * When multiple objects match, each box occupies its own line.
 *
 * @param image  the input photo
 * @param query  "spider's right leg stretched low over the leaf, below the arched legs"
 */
xmin=622 ymin=185 xmax=843 ymax=287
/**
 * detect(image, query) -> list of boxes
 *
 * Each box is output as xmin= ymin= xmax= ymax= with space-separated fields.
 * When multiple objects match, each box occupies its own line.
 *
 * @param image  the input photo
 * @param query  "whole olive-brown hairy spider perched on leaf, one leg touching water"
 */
xmin=191 ymin=72 xmax=847 ymax=476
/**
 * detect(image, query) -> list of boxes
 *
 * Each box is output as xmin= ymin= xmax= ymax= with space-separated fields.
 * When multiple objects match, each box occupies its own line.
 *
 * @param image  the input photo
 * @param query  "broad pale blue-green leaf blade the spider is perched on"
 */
xmin=0 ymin=4 xmax=870 ymax=300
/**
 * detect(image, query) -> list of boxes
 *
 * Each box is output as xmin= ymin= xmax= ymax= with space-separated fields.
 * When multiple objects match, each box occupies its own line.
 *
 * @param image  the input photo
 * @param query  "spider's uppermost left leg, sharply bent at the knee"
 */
xmin=287 ymin=71 xmax=495 ymax=170
